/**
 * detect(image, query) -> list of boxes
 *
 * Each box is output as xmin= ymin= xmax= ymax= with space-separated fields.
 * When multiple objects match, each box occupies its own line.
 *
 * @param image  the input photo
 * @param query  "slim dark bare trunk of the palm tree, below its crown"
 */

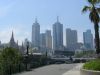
xmin=94 ymin=23 xmax=100 ymax=54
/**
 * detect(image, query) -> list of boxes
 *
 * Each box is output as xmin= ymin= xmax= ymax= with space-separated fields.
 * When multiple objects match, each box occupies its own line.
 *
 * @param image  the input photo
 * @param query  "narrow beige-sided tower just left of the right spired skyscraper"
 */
xmin=45 ymin=30 xmax=52 ymax=49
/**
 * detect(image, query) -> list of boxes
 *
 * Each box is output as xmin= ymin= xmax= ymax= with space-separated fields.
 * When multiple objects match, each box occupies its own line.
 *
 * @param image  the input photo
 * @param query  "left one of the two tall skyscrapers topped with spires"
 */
xmin=32 ymin=19 xmax=40 ymax=47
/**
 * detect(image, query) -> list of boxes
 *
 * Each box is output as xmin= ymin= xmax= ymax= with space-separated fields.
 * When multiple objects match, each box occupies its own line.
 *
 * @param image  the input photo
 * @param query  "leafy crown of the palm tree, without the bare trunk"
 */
xmin=82 ymin=0 xmax=100 ymax=23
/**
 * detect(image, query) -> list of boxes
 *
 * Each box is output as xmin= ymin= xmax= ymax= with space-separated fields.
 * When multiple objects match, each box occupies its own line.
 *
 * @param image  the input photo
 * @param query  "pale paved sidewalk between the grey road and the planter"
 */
xmin=62 ymin=63 xmax=83 ymax=75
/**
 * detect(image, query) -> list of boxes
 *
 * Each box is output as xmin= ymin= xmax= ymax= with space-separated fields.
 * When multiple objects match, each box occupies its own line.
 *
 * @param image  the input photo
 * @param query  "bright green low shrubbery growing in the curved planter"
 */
xmin=83 ymin=59 xmax=100 ymax=71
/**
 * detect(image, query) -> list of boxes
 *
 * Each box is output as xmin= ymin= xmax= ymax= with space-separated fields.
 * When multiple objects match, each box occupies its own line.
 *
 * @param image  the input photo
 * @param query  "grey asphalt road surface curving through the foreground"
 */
xmin=17 ymin=64 xmax=77 ymax=75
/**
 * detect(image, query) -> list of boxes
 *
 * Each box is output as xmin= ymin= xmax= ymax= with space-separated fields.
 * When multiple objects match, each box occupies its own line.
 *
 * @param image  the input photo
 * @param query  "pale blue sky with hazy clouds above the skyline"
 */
xmin=0 ymin=0 xmax=94 ymax=44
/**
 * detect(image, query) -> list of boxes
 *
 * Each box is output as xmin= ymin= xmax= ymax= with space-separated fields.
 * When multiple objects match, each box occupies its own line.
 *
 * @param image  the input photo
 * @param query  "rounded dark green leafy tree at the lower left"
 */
xmin=0 ymin=48 xmax=22 ymax=75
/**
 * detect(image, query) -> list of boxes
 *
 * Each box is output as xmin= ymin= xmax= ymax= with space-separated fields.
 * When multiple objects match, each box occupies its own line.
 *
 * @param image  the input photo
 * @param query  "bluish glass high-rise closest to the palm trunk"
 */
xmin=83 ymin=30 xmax=93 ymax=49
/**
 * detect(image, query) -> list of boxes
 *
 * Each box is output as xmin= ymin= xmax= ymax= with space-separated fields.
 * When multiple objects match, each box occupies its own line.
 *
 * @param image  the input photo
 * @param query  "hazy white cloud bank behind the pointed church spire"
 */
xmin=0 ymin=24 xmax=31 ymax=45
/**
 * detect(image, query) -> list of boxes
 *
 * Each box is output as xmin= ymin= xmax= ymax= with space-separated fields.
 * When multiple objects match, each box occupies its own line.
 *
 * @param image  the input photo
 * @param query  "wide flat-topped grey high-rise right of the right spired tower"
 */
xmin=66 ymin=28 xmax=77 ymax=48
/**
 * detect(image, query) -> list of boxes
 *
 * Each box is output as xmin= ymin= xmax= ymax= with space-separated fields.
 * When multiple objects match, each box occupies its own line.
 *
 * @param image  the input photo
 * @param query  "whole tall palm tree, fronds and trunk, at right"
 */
xmin=82 ymin=0 xmax=100 ymax=54
